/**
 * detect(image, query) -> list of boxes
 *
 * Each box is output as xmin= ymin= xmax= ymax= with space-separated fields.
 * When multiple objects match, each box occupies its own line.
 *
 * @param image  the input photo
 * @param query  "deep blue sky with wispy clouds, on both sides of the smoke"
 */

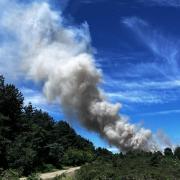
xmin=1 ymin=0 xmax=180 ymax=150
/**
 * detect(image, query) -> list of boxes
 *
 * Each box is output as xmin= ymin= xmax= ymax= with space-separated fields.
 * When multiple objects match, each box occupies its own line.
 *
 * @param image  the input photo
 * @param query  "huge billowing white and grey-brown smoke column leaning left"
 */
xmin=0 ymin=0 xmax=155 ymax=151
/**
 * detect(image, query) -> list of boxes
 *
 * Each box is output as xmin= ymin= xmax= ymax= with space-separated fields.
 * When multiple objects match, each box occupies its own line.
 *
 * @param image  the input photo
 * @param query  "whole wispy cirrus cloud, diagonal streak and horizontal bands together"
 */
xmin=100 ymin=17 xmax=180 ymax=104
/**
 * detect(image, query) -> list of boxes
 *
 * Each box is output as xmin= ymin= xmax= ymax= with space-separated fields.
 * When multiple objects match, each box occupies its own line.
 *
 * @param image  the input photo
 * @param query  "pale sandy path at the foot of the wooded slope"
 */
xmin=20 ymin=167 xmax=80 ymax=180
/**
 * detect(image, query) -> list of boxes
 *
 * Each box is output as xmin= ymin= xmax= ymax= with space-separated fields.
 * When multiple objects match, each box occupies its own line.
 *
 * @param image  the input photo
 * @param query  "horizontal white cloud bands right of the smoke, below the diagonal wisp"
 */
xmin=105 ymin=74 xmax=180 ymax=104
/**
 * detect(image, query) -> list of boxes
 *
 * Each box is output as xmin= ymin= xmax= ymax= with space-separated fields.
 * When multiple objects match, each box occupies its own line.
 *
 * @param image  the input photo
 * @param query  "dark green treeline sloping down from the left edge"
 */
xmin=0 ymin=76 xmax=95 ymax=175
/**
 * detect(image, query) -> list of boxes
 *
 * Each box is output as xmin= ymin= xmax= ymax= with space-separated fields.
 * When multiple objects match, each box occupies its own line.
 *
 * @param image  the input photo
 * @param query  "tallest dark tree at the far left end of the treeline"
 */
xmin=0 ymin=76 xmax=23 ymax=168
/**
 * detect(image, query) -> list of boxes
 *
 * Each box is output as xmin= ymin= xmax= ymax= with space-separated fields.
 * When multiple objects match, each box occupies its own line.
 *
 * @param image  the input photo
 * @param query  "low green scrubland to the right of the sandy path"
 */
xmin=76 ymin=147 xmax=180 ymax=180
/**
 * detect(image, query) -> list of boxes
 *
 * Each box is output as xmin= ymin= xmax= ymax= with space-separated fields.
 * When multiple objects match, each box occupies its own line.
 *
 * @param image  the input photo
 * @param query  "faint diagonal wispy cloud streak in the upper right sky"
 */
xmin=123 ymin=17 xmax=180 ymax=78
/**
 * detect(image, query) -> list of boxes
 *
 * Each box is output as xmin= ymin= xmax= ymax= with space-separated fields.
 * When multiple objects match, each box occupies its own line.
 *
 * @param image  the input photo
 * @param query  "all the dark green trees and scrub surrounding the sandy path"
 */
xmin=0 ymin=76 xmax=180 ymax=180
